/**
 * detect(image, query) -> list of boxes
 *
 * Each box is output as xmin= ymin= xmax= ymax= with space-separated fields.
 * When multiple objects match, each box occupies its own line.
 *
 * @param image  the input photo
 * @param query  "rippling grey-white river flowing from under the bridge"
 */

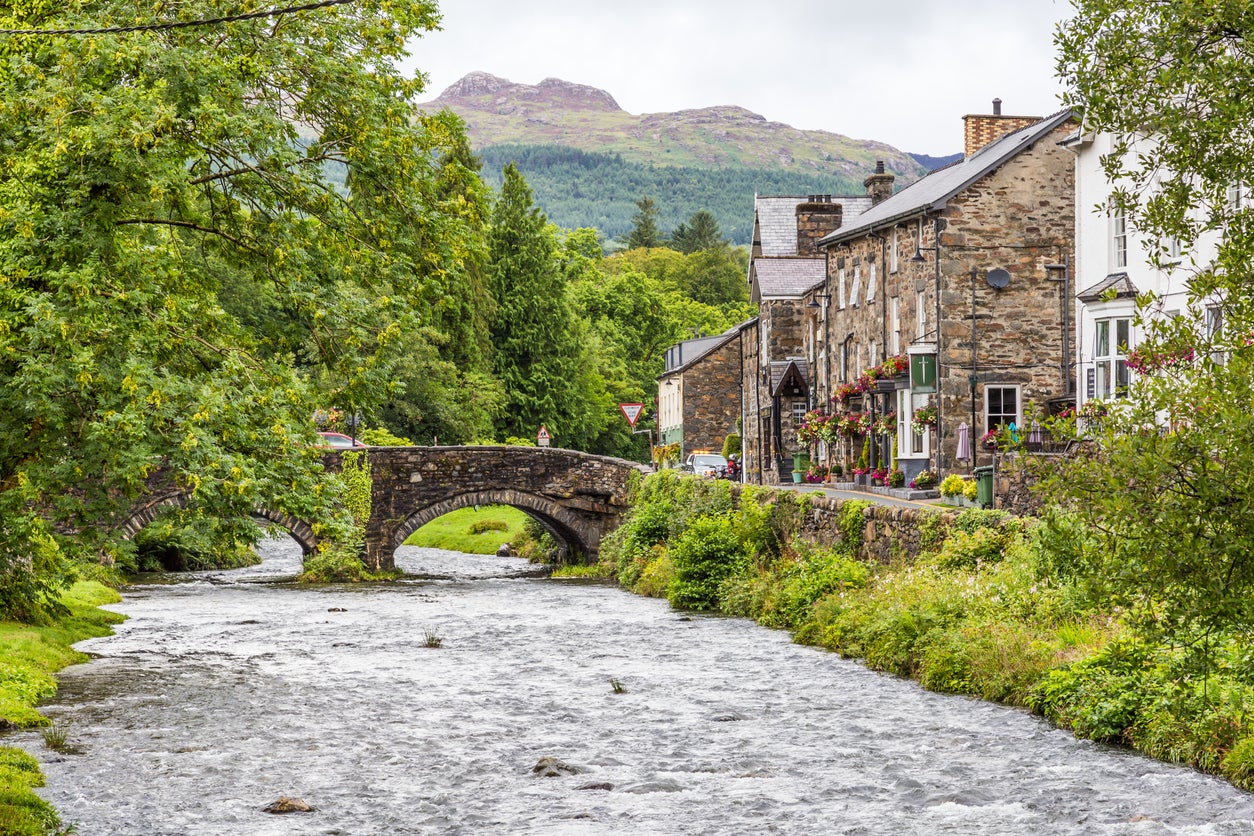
xmin=17 ymin=540 xmax=1254 ymax=836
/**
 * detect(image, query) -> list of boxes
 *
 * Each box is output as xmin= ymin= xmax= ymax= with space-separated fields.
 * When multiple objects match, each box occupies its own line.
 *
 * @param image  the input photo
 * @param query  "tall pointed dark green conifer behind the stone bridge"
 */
xmin=488 ymin=164 xmax=603 ymax=449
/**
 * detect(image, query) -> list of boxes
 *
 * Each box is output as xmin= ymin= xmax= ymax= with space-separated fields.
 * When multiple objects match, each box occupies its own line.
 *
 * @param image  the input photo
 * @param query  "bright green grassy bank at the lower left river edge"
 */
xmin=0 ymin=582 xmax=123 ymax=836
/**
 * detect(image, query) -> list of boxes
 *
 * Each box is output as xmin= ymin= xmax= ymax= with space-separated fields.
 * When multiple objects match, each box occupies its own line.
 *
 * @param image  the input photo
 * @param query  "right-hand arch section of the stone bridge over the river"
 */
xmin=328 ymin=446 xmax=650 ymax=569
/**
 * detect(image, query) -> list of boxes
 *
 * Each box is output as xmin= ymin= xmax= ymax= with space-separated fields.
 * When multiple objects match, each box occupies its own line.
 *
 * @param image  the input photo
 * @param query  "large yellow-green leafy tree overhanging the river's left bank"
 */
xmin=0 ymin=0 xmax=472 ymax=617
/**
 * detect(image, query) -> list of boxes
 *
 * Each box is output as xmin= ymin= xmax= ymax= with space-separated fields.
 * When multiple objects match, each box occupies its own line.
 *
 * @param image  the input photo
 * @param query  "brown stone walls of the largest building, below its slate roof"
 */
xmin=815 ymin=123 xmax=1075 ymax=475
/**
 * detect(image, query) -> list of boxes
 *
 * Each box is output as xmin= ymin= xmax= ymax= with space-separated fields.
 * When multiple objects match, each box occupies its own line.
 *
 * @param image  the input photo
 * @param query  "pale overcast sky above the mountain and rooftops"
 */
xmin=411 ymin=0 xmax=1071 ymax=155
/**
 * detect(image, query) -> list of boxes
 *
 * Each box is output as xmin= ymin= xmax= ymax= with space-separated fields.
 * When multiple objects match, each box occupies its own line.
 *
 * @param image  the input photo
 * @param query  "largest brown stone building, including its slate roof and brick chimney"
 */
xmin=801 ymin=112 xmax=1075 ymax=479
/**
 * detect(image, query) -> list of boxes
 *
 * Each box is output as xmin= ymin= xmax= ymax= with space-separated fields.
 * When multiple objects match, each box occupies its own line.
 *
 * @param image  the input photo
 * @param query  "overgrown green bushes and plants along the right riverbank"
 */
xmin=591 ymin=473 xmax=1254 ymax=790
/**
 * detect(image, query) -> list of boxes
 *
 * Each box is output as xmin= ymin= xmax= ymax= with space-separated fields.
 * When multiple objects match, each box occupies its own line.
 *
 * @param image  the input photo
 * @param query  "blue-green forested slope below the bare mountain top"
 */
xmin=479 ymin=144 xmax=863 ymax=244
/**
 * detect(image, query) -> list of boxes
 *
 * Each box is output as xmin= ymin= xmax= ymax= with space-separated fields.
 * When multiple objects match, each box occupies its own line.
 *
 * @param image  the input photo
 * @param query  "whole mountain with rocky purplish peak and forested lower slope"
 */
xmin=419 ymin=73 xmax=930 ymax=243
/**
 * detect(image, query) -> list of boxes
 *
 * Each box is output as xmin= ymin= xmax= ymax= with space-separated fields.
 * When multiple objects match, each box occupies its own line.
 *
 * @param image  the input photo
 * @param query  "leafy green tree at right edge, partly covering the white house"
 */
xmin=1051 ymin=0 xmax=1254 ymax=661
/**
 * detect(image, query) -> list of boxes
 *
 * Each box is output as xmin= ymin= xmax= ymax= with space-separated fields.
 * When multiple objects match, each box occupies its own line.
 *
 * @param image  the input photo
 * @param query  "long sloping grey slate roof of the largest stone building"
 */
xmin=819 ymin=108 xmax=1075 ymax=246
